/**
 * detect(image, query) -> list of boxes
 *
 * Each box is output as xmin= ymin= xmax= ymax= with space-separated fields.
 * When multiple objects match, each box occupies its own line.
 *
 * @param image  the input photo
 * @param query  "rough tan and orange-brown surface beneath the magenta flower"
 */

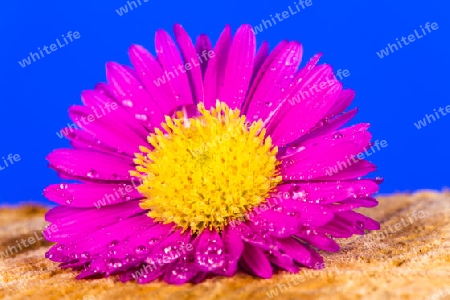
xmin=0 ymin=191 xmax=450 ymax=300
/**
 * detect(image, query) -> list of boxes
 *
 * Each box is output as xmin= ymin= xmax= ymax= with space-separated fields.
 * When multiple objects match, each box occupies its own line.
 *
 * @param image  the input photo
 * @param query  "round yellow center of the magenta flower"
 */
xmin=130 ymin=101 xmax=281 ymax=233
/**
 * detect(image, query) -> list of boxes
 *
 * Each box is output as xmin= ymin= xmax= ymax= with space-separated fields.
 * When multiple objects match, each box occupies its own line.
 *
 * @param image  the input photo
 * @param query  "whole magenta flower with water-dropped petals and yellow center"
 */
xmin=45 ymin=25 xmax=379 ymax=284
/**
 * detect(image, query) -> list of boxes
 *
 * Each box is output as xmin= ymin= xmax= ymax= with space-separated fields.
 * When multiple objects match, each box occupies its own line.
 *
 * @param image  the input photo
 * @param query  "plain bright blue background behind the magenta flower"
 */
xmin=0 ymin=0 xmax=450 ymax=204
